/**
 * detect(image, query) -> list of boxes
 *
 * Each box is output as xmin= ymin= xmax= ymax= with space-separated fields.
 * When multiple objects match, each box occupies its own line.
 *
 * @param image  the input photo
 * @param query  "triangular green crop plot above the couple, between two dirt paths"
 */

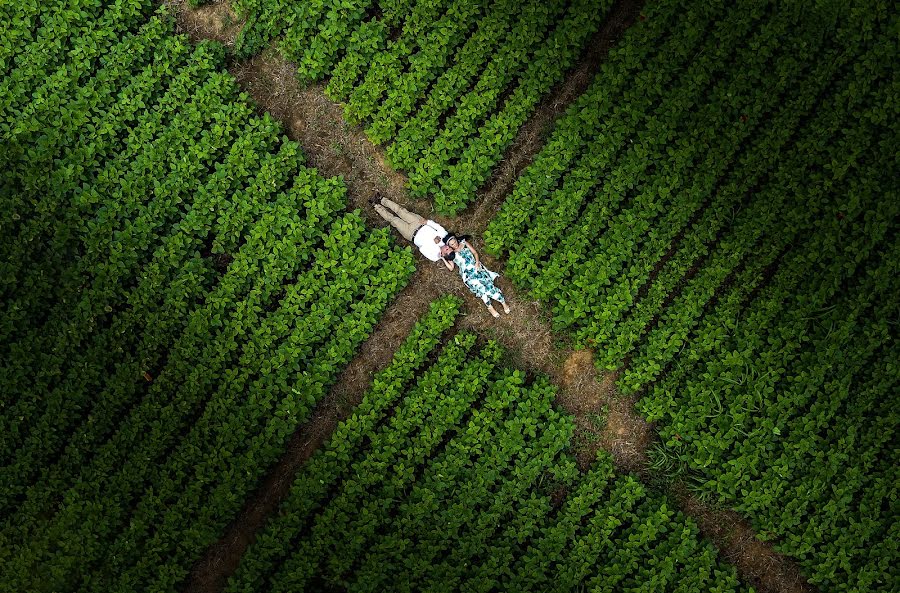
xmin=227 ymin=0 xmax=612 ymax=214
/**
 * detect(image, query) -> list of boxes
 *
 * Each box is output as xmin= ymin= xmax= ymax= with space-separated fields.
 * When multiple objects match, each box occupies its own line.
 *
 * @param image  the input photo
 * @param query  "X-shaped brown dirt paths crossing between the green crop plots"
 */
xmin=167 ymin=0 xmax=812 ymax=593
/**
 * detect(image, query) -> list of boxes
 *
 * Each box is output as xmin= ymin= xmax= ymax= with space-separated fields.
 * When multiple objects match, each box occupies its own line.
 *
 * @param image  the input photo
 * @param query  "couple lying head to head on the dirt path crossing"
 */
xmin=370 ymin=194 xmax=509 ymax=317
